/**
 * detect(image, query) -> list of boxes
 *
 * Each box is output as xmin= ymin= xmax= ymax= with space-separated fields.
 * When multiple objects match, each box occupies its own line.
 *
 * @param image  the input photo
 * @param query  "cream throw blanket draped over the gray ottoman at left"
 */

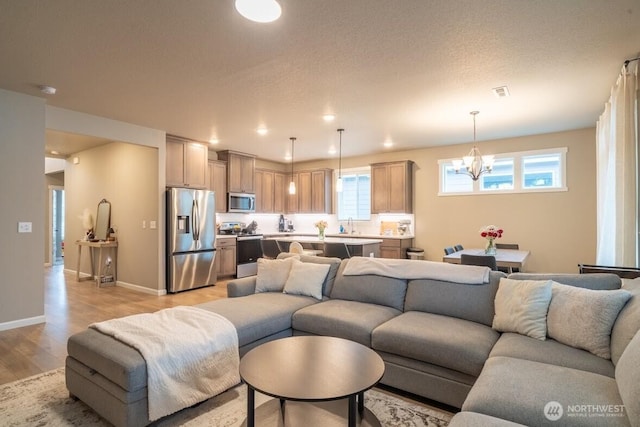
xmin=89 ymin=306 xmax=240 ymax=421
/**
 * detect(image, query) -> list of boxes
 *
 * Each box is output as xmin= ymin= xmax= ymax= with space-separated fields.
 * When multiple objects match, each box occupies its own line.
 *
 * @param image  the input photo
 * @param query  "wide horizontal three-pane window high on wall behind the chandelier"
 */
xmin=438 ymin=147 xmax=567 ymax=195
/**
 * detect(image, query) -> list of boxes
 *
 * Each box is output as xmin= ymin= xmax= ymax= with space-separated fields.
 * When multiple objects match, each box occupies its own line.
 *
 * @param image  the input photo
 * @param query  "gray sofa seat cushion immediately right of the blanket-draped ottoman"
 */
xmin=195 ymin=292 xmax=318 ymax=347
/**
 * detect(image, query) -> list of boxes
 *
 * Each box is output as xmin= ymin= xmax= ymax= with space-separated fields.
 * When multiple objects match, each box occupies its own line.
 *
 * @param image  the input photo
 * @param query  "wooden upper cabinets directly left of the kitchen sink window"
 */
xmin=286 ymin=169 xmax=333 ymax=213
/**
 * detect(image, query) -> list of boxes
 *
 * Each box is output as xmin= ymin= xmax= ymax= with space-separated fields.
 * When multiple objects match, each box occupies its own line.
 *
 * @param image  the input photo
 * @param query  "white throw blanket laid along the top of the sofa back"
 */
xmin=342 ymin=257 xmax=491 ymax=285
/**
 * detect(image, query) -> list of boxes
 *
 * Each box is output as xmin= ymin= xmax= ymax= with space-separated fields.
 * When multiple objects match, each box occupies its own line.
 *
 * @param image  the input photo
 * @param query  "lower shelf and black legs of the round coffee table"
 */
xmin=242 ymin=399 xmax=381 ymax=427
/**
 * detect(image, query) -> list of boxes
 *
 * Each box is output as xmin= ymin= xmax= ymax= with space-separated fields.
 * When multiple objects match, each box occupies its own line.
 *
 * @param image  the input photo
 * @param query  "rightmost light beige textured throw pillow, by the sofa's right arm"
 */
xmin=547 ymin=282 xmax=631 ymax=359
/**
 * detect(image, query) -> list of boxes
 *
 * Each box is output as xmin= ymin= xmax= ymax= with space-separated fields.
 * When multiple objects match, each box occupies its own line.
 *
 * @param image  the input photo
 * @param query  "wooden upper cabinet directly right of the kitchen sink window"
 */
xmin=371 ymin=160 xmax=413 ymax=214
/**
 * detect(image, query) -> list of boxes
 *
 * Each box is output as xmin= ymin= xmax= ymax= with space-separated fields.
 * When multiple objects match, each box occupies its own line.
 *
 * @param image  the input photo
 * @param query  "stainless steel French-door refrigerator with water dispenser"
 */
xmin=167 ymin=188 xmax=216 ymax=293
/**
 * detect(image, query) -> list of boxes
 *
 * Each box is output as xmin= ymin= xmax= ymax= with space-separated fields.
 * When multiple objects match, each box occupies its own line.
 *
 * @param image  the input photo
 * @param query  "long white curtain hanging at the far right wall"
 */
xmin=596 ymin=61 xmax=640 ymax=267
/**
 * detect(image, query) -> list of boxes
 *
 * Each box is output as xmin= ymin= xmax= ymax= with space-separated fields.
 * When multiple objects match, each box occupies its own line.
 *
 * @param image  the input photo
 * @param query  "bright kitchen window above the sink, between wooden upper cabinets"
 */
xmin=336 ymin=168 xmax=371 ymax=221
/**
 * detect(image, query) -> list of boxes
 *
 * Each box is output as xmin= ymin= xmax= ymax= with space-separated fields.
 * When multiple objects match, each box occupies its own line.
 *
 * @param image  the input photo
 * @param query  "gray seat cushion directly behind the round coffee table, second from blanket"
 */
xmin=293 ymin=300 xmax=401 ymax=347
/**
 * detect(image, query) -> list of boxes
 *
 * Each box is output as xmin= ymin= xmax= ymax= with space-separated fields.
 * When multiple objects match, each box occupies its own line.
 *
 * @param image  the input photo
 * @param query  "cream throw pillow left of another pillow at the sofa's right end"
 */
xmin=493 ymin=278 xmax=551 ymax=341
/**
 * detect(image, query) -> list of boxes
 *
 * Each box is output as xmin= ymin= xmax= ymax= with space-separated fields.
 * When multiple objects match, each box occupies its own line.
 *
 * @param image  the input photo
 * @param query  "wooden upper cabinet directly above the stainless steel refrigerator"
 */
xmin=166 ymin=135 xmax=209 ymax=188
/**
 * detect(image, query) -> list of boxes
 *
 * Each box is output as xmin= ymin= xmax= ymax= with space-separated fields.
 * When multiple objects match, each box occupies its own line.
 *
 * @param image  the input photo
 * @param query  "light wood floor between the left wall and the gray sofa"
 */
xmin=0 ymin=265 xmax=227 ymax=384
